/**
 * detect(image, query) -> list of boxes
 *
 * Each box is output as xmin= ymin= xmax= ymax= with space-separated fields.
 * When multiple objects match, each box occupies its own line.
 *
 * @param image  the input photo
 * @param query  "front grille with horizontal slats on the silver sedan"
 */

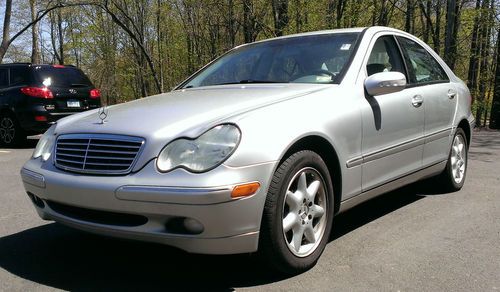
xmin=55 ymin=134 xmax=144 ymax=174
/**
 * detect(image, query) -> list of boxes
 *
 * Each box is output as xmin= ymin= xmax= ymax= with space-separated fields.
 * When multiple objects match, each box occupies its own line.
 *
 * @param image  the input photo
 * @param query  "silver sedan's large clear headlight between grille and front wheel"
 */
xmin=156 ymin=124 xmax=241 ymax=172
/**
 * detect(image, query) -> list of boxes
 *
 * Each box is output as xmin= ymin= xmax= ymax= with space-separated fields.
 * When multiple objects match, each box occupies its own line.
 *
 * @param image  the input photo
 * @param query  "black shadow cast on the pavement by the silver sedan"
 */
xmin=0 ymin=180 xmax=444 ymax=291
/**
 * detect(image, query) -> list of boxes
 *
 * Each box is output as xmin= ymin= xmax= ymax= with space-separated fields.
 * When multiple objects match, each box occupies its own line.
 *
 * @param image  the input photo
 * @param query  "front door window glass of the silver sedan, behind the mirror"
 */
xmin=366 ymin=35 xmax=406 ymax=76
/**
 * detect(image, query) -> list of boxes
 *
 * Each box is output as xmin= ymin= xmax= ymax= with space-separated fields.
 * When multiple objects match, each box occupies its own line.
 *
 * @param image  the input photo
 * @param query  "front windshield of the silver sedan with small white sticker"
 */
xmin=180 ymin=33 xmax=359 ymax=88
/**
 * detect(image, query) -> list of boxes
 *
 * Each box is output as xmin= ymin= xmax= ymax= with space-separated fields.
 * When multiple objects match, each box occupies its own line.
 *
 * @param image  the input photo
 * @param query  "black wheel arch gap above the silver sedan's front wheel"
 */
xmin=277 ymin=135 xmax=342 ymax=214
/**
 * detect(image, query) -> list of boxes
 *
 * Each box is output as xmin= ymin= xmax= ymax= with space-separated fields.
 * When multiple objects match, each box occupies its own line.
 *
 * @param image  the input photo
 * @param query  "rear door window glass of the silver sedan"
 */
xmin=398 ymin=37 xmax=449 ymax=84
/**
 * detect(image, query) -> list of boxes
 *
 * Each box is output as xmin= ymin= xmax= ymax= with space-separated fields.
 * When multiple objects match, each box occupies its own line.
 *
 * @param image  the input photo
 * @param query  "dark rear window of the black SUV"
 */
xmin=34 ymin=66 xmax=92 ymax=87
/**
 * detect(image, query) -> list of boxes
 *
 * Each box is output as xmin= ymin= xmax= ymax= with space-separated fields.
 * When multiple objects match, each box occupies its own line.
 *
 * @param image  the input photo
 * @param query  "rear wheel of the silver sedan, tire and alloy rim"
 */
xmin=438 ymin=128 xmax=469 ymax=192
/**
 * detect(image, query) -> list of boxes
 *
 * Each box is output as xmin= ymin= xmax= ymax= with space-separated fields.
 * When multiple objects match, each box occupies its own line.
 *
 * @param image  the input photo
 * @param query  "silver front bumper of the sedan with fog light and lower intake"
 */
xmin=21 ymin=159 xmax=276 ymax=254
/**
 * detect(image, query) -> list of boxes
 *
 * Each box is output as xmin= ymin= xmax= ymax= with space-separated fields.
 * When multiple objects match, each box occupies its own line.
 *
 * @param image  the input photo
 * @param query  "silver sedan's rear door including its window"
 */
xmin=397 ymin=37 xmax=457 ymax=167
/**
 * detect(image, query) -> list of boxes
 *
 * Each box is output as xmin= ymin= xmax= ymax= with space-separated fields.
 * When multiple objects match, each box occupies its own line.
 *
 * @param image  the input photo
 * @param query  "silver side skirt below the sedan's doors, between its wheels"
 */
xmin=338 ymin=160 xmax=446 ymax=213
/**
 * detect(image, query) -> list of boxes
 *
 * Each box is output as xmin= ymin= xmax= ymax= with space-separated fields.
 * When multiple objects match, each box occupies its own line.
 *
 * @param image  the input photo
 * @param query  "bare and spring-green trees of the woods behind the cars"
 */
xmin=0 ymin=0 xmax=500 ymax=128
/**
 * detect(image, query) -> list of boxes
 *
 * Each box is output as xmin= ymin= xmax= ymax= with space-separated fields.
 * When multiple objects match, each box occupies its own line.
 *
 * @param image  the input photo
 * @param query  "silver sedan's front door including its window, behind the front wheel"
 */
xmin=361 ymin=35 xmax=424 ymax=191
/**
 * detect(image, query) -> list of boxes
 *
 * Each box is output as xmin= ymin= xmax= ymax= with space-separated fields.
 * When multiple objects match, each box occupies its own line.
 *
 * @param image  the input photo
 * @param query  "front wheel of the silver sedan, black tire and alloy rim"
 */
xmin=259 ymin=150 xmax=334 ymax=274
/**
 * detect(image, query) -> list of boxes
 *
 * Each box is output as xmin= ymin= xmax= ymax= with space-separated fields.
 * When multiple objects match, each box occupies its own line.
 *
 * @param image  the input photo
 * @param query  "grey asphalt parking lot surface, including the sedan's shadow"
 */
xmin=0 ymin=131 xmax=500 ymax=291
